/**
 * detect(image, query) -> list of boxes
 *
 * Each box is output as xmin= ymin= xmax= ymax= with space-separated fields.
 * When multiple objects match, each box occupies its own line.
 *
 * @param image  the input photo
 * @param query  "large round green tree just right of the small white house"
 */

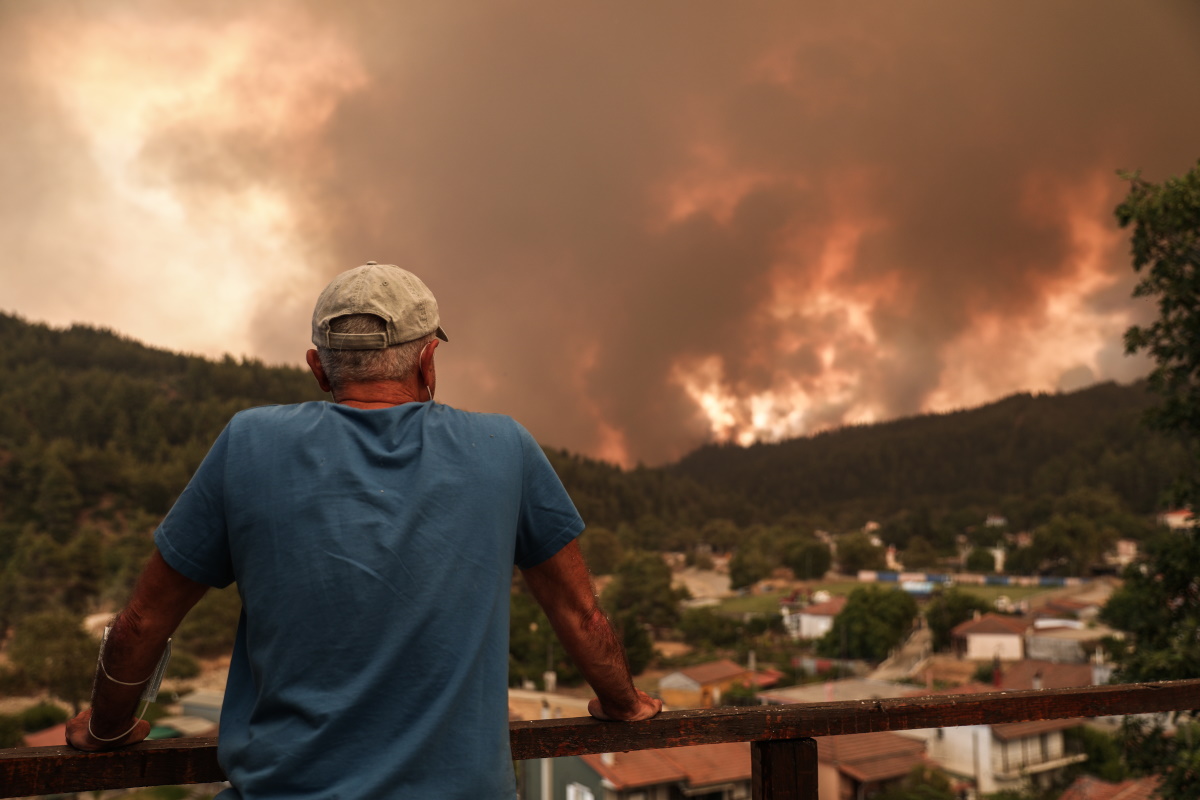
xmin=817 ymin=585 xmax=917 ymax=661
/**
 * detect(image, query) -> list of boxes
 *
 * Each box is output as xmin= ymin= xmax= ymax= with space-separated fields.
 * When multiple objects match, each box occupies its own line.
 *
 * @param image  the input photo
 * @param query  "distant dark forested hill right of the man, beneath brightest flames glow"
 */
xmin=671 ymin=383 xmax=1183 ymax=528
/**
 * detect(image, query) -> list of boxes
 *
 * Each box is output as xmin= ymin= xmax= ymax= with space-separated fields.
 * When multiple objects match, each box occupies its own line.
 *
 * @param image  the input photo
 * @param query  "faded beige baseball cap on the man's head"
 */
xmin=312 ymin=261 xmax=450 ymax=350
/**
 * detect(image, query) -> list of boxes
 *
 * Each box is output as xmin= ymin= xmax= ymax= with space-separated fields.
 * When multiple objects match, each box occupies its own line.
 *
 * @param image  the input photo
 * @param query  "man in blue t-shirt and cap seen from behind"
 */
xmin=67 ymin=261 xmax=661 ymax=800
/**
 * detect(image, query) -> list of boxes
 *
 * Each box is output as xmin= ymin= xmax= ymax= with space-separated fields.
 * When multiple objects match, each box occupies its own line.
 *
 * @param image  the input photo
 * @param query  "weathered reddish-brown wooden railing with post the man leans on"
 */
xmin=0 ymin=679 xmax=1200 ymax=800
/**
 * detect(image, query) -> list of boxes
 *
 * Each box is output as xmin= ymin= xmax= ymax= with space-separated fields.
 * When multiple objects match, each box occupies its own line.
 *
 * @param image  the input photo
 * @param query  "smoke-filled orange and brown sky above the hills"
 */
xmin=0 ymin=0 xmax=1200 ymax=464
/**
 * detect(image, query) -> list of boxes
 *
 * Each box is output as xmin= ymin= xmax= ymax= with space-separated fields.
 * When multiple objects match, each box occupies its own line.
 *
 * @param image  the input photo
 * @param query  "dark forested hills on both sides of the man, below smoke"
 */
xmin=0 ymin=314 xmax=1182 ymax=630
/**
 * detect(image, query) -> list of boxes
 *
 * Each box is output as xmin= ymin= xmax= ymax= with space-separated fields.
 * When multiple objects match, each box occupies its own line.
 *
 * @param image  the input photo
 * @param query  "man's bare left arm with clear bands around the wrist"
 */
xmin=67 ymin=549 xmax=208 ymax=751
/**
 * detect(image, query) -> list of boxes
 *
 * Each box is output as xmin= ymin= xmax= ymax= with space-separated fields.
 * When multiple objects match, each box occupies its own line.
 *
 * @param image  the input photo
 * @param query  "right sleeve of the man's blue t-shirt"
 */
xmin=514 ymin=425 xmax=583 ymax=570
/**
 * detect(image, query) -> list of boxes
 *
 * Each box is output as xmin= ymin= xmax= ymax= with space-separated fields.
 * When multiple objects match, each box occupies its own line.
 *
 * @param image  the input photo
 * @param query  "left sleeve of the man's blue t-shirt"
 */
xmin=154 ymin=426 xmax=234 ymax=589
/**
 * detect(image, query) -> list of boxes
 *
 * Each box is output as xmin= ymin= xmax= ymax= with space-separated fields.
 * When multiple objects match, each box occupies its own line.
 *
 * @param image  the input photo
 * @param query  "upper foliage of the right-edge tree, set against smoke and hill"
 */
xmin=1116 ymin=163 xmax=1200 ymax=507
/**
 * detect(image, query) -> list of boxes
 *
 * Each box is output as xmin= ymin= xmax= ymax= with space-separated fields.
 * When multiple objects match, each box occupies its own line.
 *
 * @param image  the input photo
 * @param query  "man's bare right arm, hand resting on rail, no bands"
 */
xmin=522 ymin=541 xmax=662 ymax=721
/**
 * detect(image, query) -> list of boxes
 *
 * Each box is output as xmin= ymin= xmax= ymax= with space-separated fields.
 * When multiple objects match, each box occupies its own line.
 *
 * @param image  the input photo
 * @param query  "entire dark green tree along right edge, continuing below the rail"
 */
xmin=1103 ymin=164 xmax=1200 ymax=800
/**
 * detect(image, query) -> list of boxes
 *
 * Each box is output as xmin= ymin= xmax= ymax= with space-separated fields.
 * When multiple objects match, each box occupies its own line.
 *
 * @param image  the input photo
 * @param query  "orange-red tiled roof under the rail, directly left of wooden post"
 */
xmin=580 ymin=741 xmax=750 ymax=792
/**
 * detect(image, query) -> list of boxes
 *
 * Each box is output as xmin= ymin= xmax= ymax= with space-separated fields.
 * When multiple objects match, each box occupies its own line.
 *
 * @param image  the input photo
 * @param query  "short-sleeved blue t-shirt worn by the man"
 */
xmin=155 ymin=403 xmax=583 ymax=800
